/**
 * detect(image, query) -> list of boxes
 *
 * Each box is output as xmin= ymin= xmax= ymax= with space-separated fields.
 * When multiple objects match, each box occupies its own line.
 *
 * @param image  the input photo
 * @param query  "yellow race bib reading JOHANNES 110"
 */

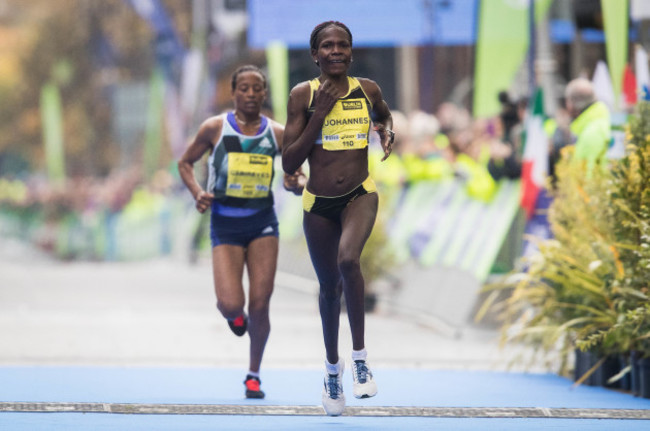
xmin=323 ymin=99 xmax=370 ymax=151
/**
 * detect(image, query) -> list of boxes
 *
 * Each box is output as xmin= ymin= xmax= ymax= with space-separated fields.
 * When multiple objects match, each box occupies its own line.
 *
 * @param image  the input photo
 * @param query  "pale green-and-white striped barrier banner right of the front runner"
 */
xmin=388 ymin=179 xmax=520 ymax=281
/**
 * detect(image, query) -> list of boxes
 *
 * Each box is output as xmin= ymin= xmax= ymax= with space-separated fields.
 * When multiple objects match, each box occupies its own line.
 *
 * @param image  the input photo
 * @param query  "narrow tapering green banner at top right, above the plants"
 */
xmin=600 ymin=0 xmax=628 ymax=109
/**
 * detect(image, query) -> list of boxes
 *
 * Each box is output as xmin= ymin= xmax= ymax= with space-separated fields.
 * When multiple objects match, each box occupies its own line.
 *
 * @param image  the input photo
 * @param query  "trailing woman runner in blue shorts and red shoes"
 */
xmin=178 ymin=66 xmax=304 ymax=398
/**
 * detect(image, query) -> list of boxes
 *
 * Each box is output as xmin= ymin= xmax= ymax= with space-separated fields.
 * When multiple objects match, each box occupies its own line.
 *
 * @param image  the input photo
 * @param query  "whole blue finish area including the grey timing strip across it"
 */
xmin=0 ymin=366 xmax=650 ymax=431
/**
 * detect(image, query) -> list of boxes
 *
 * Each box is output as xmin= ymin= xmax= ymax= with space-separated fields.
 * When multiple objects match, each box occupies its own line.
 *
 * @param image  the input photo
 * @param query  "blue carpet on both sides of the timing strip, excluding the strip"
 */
xmin=0 ymin=367 xmax=650 ymax=431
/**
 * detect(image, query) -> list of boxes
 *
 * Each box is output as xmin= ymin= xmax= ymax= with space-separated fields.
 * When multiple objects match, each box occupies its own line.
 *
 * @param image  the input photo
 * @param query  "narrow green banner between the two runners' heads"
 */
xmin=266 ymin=41 xmax=289 ymax=124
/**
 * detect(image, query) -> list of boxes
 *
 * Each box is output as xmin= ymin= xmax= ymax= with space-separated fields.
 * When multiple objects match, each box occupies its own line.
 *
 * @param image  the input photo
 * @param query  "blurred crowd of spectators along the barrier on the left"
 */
xmin=0 ymin=168 xmax=176 ymax=258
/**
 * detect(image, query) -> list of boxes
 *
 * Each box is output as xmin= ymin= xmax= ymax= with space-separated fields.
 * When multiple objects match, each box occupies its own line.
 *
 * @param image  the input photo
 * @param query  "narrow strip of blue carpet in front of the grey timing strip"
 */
xmin=0 ymin=413 xmax=650 ymax=431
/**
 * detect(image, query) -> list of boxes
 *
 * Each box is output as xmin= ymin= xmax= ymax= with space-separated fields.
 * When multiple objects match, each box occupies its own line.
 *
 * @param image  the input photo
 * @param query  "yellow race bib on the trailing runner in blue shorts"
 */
xmin=226 ymin=153 xmax=273 ymax=199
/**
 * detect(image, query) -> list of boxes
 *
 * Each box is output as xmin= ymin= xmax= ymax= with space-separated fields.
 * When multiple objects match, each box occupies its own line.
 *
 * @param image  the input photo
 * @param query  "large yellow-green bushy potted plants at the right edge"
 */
xmin=477 ymin=102 xmax=650 ymax=396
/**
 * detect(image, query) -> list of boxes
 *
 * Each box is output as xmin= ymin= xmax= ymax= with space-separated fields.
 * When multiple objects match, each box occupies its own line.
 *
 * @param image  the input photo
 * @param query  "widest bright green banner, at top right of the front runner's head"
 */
xmin=474 ymin=0 xmax=551 ymax=118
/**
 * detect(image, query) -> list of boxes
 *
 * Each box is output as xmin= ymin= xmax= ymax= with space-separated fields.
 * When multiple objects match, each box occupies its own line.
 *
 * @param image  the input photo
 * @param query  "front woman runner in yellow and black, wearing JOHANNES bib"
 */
xmin=282 ymin=21 xmax=393 ymax=415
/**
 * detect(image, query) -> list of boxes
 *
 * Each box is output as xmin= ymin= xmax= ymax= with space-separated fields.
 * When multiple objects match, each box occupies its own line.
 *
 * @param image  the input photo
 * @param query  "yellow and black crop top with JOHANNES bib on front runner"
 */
xmin=308 ymin=76 xmax=372 ymax=151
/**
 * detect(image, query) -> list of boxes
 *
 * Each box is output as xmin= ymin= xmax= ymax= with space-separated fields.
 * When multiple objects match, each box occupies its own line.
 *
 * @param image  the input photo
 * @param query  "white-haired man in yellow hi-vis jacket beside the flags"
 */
xmin=565 ymin=78 xmax=612 ymax=172
